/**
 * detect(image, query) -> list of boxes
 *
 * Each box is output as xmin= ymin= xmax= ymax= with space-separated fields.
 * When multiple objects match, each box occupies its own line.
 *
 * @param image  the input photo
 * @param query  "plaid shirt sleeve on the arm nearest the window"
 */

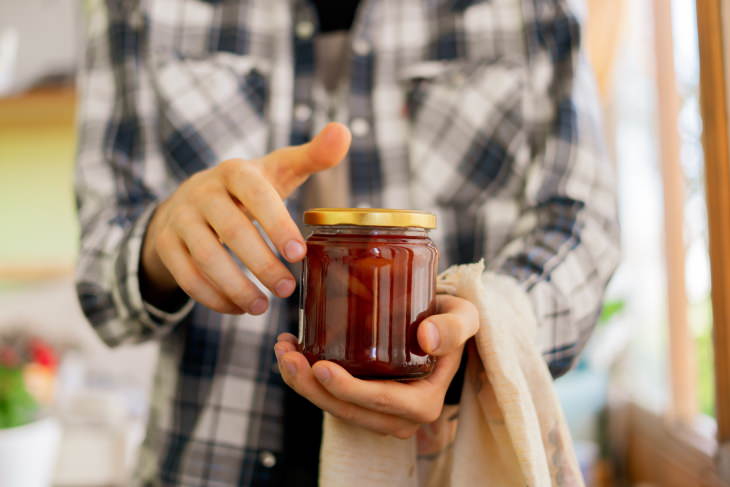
xmin=489 ymin=1 xmax=619 ymax=377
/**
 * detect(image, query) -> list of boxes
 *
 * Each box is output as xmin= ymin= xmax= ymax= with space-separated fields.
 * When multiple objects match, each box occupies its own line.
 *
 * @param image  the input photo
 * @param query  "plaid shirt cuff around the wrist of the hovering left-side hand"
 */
xmin=115 ymin=203 xmax=195 ymax=334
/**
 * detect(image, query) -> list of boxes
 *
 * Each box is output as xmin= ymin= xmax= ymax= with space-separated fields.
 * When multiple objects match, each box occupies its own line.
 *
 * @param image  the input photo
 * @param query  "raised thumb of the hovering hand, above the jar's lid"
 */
xmin=261 ymin=122 xmax=352 ymax=198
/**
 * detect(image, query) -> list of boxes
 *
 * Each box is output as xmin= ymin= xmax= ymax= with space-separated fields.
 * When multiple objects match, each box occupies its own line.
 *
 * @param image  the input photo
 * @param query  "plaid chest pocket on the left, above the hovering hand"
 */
xmin=151 ymin=52 xmax=269 ymax=178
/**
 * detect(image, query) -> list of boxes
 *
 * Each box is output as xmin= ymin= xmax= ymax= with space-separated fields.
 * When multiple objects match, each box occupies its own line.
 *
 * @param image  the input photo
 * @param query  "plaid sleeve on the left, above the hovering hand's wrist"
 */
xmin=75 ymin=1 xmax=193 ymax=345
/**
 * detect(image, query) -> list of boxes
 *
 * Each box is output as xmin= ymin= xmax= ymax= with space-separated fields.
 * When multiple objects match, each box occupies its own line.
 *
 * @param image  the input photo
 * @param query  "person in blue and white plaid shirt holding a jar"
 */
xmin=76 ymin=0 xmax=618 ymax=486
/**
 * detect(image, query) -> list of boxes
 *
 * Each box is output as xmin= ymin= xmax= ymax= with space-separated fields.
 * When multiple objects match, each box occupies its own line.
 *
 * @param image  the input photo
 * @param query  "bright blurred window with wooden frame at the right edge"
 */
xmin=604 ymin=0 xmax=730 ymax=486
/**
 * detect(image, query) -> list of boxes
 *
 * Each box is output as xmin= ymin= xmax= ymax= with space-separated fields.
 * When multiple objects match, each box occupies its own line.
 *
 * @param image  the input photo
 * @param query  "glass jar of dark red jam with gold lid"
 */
xmin=299 ymin=208 xmax=438 ymax=379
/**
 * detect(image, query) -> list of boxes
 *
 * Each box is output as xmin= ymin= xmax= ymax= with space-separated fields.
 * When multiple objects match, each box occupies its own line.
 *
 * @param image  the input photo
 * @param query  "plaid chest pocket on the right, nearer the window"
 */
xmin=399 ymin=60 xmax=528 ymax=209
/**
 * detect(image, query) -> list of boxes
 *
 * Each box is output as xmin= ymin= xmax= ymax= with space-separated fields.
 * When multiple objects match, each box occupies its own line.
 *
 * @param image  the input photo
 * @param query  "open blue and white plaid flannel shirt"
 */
xmin=76 ymin=0 xmax=618 ymax=486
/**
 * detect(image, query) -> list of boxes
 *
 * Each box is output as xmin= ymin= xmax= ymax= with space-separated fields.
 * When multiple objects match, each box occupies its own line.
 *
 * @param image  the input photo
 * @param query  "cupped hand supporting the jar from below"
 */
xmin=274 ymin=295 xmax=479 ymax=438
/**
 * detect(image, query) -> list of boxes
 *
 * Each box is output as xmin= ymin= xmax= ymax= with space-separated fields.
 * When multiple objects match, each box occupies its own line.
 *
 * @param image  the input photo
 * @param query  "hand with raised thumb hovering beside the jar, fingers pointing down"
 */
xmin=141 ymin=123 xmax=351 ymax=315
